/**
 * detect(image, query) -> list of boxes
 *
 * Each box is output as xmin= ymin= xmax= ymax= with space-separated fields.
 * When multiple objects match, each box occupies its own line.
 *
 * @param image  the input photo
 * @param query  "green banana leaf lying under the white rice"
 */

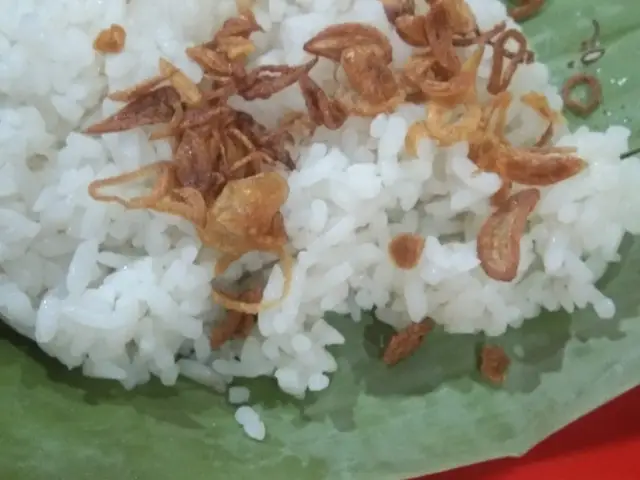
xmin=0 ymin=0 xmax=640 ymax=480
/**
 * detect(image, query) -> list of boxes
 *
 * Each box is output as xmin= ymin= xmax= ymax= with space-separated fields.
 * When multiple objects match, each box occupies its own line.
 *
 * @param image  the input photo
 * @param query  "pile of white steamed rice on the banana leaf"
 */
xmin=0 ymin=0 xmax=640 ymax=438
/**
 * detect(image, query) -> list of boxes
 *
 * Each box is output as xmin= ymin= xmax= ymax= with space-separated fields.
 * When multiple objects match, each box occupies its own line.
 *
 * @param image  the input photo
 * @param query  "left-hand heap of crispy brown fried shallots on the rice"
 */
xmin=85 ymin=10 xmax=304 ymax=318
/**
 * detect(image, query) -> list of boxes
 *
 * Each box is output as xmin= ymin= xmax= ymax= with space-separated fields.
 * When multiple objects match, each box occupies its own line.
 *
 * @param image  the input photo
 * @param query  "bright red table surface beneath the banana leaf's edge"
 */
xmin=420 ymin=387 xmax=640 ymax=480
